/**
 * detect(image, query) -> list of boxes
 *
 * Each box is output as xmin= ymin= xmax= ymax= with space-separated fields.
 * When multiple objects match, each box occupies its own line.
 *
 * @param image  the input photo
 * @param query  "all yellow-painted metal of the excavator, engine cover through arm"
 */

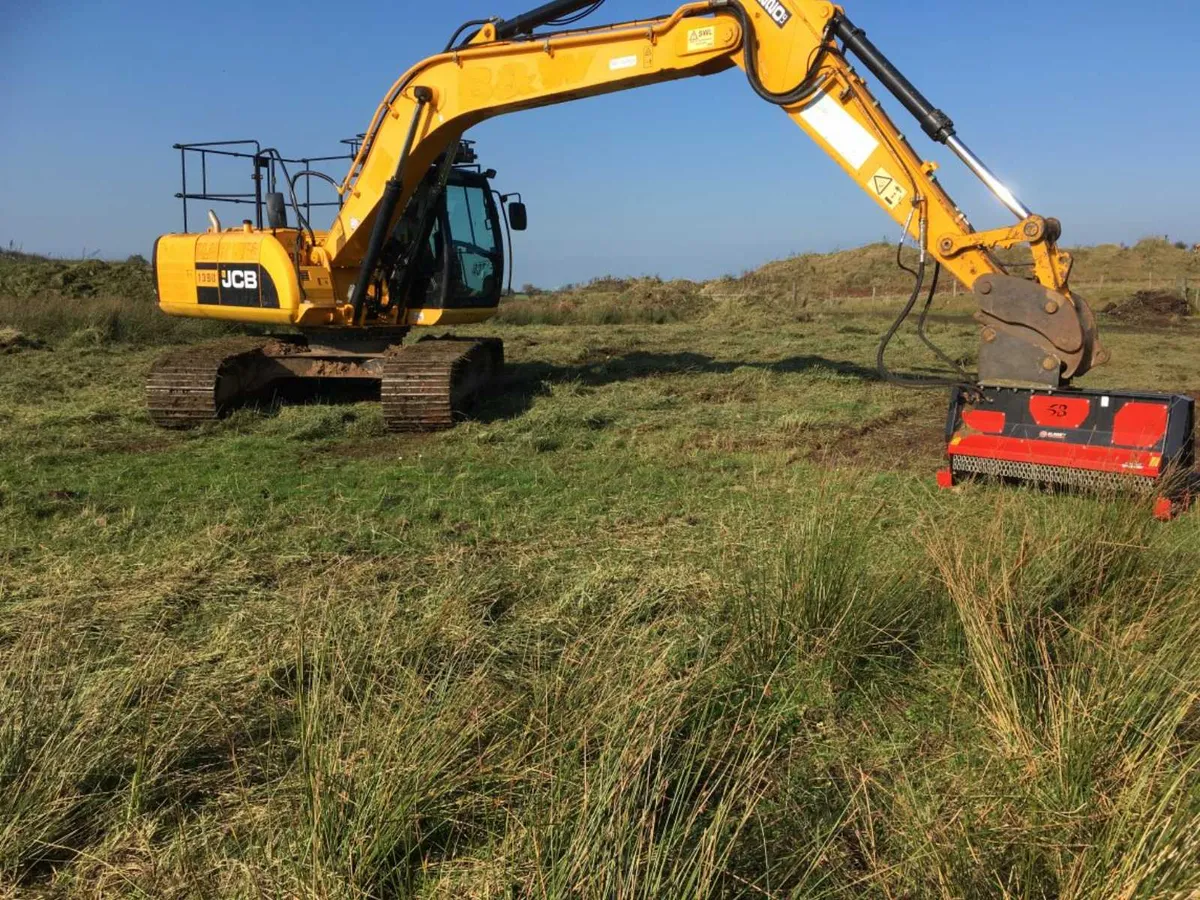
xmin=160 ymin=0 xmax=1099 ymax=374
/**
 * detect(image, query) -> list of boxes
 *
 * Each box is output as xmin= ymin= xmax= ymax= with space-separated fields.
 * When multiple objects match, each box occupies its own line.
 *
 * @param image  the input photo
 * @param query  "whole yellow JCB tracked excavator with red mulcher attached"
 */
xmin=148 ymin=0 xmax=1192 ymax=508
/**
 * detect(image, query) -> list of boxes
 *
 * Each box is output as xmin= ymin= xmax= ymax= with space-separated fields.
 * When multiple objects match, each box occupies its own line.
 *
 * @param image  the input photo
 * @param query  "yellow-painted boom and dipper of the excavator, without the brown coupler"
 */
xmin=325 ymin=0 xmax=1067 ymax=309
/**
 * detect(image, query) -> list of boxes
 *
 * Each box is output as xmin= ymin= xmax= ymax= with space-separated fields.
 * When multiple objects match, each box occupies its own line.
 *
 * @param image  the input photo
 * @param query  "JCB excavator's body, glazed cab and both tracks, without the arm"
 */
xmin=146 ymin=139 xmax=527 ymax=431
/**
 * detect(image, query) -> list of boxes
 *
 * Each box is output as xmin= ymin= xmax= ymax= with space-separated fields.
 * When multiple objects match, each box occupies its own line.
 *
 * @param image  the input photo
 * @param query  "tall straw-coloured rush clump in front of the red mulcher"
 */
xmin=907 ymin=503 xmax=1200 ymax=898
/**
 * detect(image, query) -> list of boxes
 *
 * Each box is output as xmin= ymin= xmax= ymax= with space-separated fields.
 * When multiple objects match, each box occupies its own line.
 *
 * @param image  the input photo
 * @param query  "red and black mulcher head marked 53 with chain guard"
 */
xmin=937 ymin=388 xmax=1195 ymax=520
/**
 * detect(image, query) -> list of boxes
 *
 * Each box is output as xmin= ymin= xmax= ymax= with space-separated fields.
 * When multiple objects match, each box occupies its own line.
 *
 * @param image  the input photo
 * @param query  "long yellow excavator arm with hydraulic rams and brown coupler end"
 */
xmin=326 ymin=0 xmax=1106 ymax=388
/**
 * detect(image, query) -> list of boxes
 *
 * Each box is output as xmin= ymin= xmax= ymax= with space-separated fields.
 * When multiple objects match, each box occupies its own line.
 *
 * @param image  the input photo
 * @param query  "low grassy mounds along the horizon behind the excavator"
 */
xmin=0 ymin=239 xmax=1200 ymax=343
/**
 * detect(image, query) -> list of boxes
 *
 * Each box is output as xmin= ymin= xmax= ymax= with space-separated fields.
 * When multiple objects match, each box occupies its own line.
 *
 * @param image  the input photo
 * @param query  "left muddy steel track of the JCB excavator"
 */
xmin=146 ymin=338 xmax=268 ymax=428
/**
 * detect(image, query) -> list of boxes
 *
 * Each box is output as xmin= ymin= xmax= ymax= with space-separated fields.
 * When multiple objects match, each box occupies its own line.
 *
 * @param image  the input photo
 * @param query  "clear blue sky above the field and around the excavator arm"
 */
xmin=0 ymin=0 xmax=1200 ymax=286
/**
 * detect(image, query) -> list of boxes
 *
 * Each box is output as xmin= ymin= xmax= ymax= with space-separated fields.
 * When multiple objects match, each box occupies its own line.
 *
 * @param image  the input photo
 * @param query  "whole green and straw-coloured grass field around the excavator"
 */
xmin=0 ymin=243 xmax=1200 ymax=900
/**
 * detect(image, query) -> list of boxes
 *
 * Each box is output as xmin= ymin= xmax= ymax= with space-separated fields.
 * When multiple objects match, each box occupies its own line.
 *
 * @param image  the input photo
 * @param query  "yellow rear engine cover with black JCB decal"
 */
xmin=154 ymin=229 xmax=309 ymax=325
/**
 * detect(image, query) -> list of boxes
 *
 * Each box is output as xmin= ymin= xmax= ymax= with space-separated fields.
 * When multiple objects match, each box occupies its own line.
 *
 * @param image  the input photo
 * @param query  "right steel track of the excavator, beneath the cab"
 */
xmin=380 ymin=337 xmax=504 ymax=432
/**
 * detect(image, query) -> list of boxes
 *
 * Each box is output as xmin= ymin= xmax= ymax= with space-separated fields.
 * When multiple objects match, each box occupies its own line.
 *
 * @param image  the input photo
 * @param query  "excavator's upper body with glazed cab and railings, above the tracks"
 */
xmin=164 ymin=139 xmax=527 ymax=330
